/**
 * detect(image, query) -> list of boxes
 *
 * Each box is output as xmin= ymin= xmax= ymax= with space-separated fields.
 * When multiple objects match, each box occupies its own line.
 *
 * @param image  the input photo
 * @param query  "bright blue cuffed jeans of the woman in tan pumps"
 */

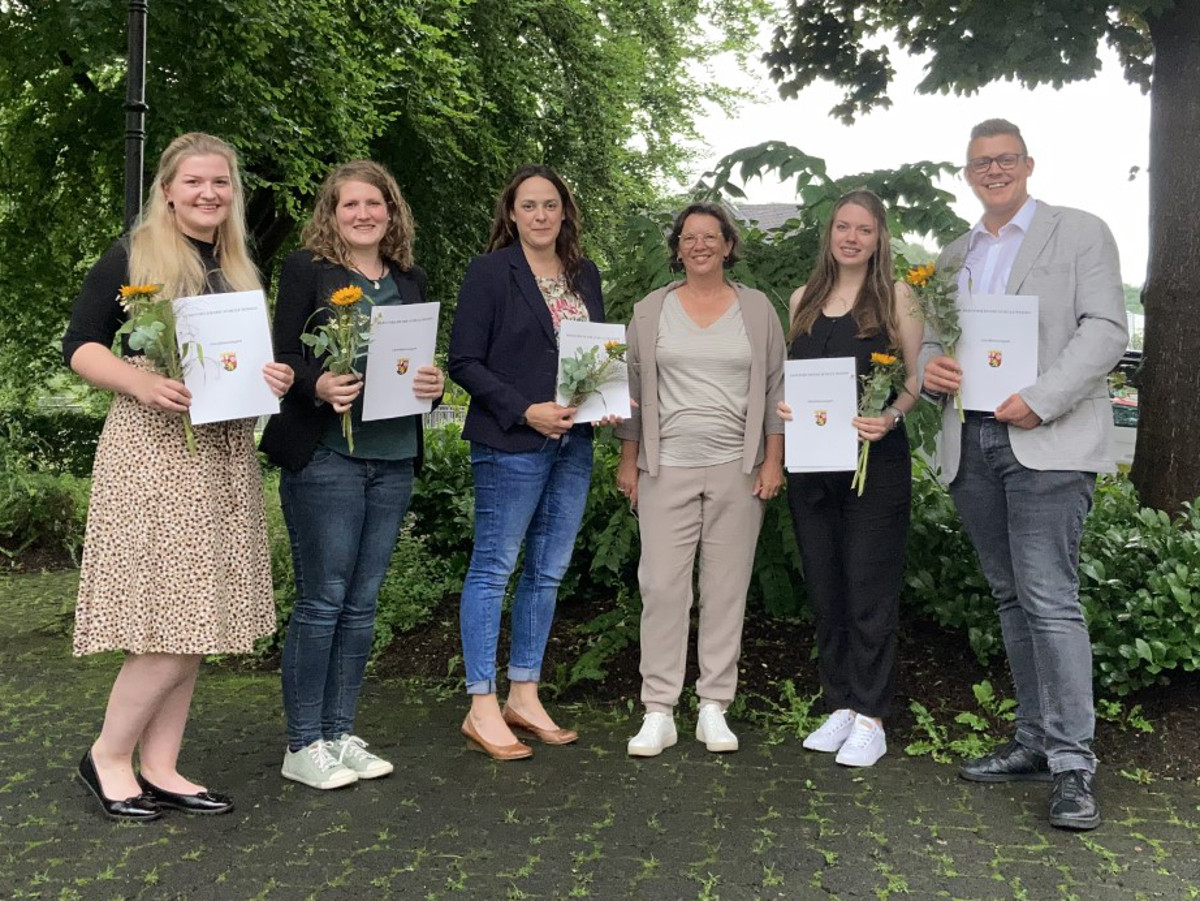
xmin=460 ymin=433 xmax=592 ymax=695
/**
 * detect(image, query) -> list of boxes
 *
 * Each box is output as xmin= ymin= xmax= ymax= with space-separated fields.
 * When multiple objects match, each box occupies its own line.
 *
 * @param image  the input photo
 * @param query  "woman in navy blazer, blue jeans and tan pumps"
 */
xmin=449 ymin=166 xmax=604 ymax=759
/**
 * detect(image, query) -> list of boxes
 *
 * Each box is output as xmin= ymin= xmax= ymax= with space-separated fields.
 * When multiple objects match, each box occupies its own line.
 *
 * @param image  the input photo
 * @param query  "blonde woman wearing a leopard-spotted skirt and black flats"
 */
xmin=62 ymin=133 xmax=293 ymax=821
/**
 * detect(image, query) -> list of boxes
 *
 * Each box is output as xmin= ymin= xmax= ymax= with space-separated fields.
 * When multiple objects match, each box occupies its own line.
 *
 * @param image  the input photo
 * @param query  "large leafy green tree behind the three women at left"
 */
xmin=0 ymin=0 xmax=764 ymax=395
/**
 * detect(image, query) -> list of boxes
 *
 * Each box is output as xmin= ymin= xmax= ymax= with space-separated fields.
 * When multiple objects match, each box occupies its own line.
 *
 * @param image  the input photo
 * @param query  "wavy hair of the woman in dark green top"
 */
xmin=300 ymin=160 xmax=416 ymax=272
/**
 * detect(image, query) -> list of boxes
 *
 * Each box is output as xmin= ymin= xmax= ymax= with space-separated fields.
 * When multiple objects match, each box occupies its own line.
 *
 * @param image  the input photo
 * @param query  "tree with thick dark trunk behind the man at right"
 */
xmin=764 ymin=0 xmax=1200 ymax=510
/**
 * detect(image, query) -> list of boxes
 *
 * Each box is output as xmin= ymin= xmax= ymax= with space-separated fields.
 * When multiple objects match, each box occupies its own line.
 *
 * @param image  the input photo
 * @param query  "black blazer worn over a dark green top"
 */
xmin=259 ymin=250 xmax=425 ymax=473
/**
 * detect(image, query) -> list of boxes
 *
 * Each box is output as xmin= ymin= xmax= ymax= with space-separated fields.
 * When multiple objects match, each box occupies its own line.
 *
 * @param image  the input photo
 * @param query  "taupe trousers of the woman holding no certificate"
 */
xmin=637 ymin=459 xmax=764 ymax=714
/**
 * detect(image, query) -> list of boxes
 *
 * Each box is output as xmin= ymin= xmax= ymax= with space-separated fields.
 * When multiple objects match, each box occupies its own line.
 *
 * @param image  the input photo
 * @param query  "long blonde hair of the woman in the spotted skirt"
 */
xmin=130 ymin=132 xmax=263 ymax=298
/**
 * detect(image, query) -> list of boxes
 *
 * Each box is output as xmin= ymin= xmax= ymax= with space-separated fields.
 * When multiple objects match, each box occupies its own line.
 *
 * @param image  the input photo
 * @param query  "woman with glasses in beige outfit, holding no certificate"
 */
xmin=617 ymin=203 xmax=784 ymax=757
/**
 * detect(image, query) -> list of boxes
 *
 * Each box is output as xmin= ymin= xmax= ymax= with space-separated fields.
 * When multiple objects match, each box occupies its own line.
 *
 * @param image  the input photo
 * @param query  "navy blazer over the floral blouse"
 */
xmin=449 ymin=242 xmax=604 ymax=452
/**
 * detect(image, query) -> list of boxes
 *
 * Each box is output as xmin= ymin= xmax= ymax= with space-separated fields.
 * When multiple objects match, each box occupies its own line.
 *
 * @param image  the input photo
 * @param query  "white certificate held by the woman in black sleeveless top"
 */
xmin=784 ymin=356 xmax=858 ymax=473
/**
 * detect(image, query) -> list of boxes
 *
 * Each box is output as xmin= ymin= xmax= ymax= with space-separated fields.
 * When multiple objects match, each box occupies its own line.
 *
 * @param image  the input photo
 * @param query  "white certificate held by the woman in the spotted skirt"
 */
xmin=173 ymin=290 xmax=280 ymax=426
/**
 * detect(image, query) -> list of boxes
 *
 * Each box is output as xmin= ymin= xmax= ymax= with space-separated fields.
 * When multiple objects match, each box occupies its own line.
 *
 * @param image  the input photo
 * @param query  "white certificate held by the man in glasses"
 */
xmin=954 ymin=294 xmax=1038 ymax=413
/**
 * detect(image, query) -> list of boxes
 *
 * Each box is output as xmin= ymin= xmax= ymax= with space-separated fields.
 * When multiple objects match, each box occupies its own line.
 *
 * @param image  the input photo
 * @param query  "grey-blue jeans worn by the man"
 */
xmin=950 ymin=418 xmax=1096 ymax=773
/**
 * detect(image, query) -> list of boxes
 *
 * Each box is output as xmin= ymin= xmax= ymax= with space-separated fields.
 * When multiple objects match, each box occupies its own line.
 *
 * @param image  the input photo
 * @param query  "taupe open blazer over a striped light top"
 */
xmin=617 ymin=282 xmax=785 ymax=476
